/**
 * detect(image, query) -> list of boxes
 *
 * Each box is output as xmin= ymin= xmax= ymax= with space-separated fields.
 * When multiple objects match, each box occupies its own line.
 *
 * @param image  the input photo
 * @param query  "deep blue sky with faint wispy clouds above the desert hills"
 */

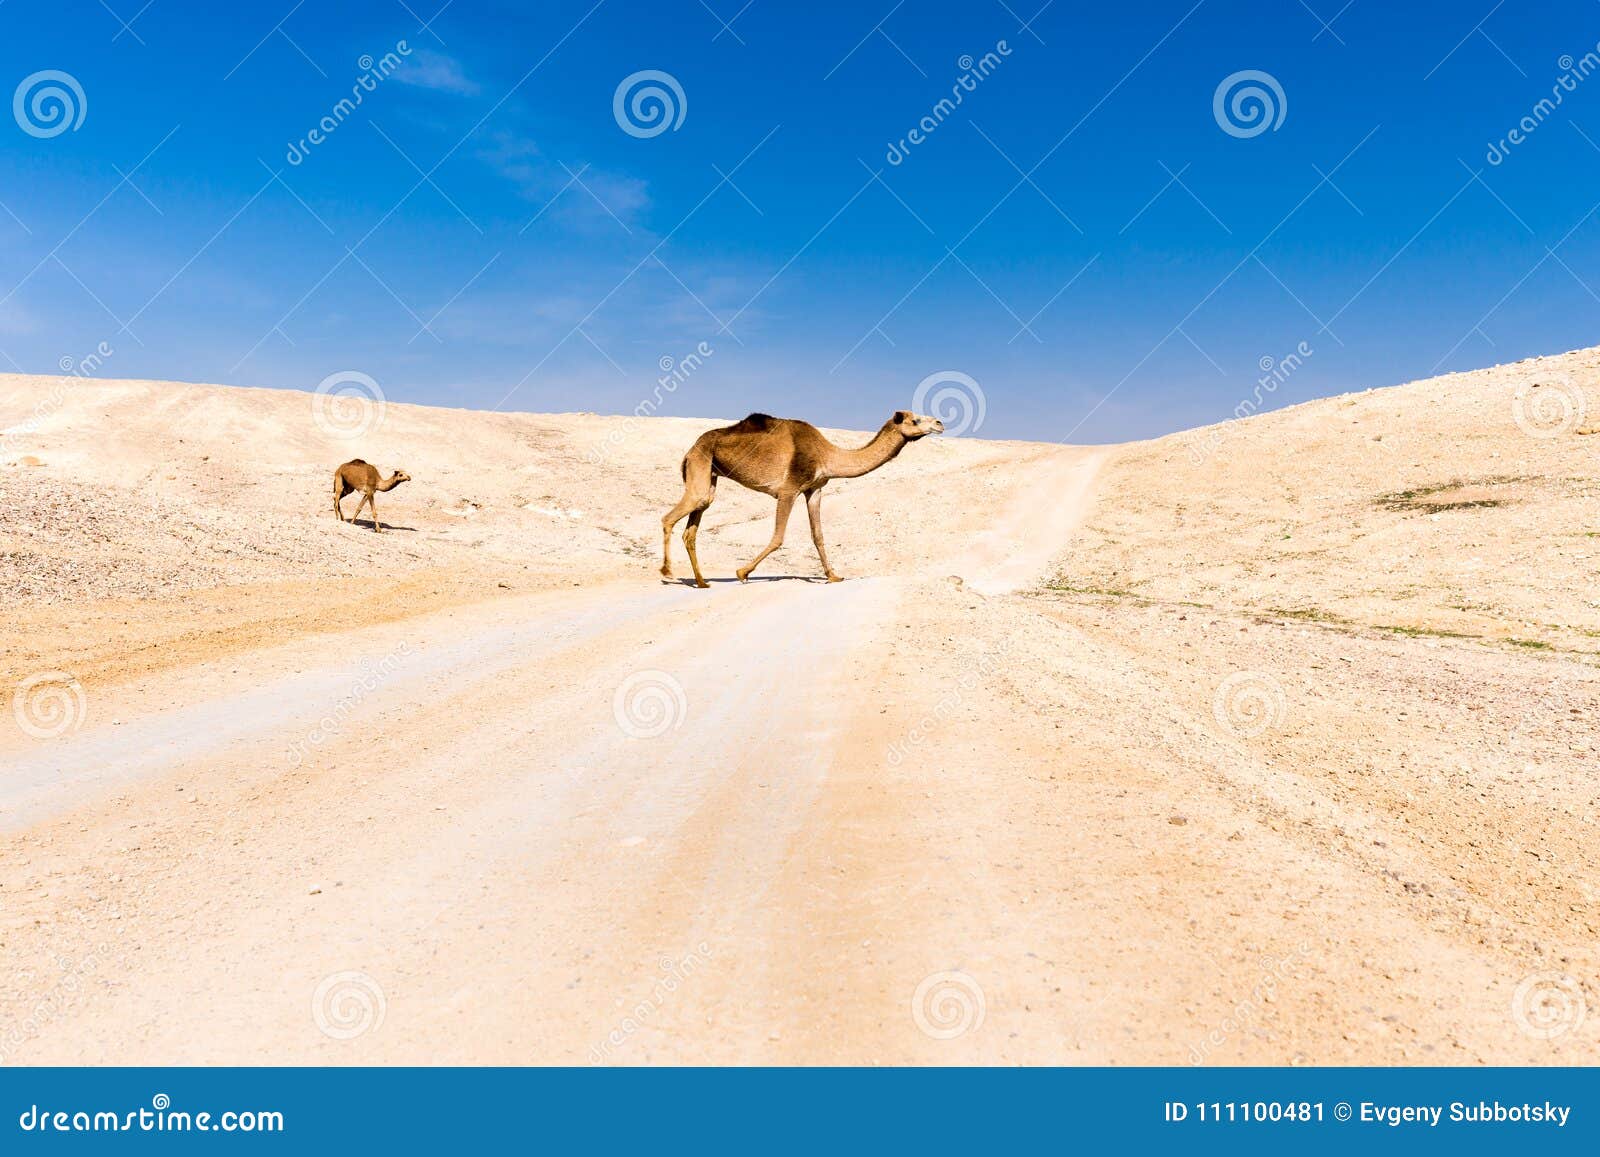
xmin=0 ymin=0 xmax=1600 ymax=442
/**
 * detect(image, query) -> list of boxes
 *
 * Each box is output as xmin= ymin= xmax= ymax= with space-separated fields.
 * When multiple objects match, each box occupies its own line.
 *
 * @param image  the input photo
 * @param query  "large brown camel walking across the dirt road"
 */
xmin=661 ymin=410 xmax=944 ymax=589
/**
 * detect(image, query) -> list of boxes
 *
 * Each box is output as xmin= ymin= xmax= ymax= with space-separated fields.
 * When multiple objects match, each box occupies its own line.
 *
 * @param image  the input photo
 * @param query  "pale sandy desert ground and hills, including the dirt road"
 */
xmin=0 ymin=352 xmax=1600 ymax=1064
